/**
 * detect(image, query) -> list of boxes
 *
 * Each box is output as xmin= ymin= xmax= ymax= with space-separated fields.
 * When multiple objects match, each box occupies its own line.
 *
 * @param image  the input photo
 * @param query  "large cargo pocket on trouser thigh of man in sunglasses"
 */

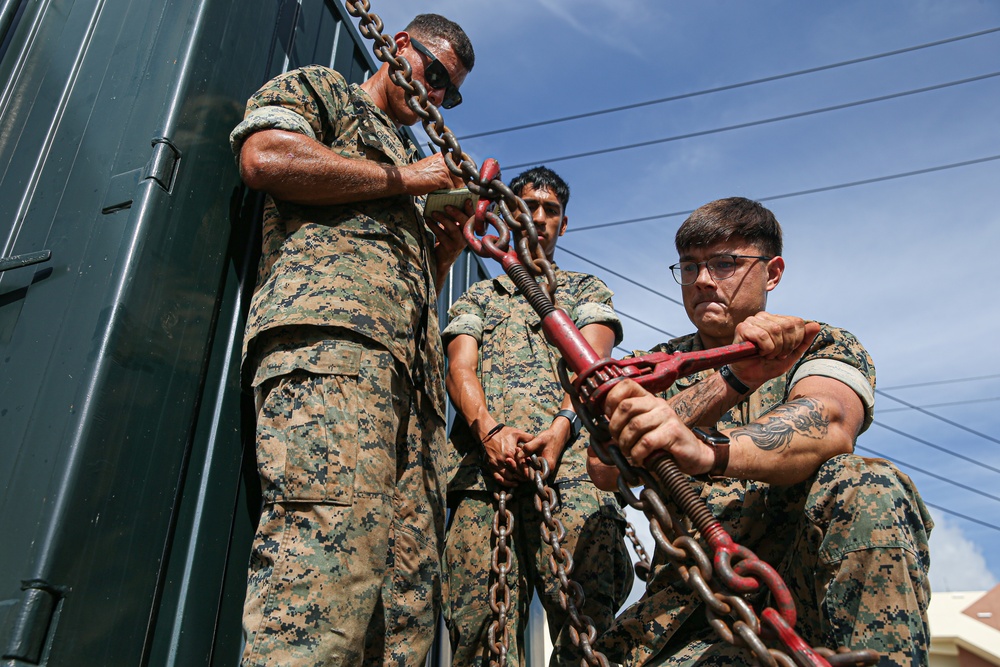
xmin=257 ymin=348 xmax=361 ymax=505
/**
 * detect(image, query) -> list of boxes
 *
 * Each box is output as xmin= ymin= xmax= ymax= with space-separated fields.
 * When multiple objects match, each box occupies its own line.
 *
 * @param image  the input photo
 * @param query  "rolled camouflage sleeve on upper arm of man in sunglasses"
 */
xmin=229 ymin=66 xmax=347 ymax=161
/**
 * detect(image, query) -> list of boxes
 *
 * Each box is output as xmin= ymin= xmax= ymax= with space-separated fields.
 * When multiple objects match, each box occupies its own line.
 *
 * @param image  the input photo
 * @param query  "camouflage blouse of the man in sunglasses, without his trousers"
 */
xmin=230 ymin=66 xmax=444 ymax=415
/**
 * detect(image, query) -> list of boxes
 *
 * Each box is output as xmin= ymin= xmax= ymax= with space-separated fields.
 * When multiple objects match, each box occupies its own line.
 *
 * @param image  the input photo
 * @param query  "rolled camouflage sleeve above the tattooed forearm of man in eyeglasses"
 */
xmin=788 ymin=325 xmax=875 ymax=433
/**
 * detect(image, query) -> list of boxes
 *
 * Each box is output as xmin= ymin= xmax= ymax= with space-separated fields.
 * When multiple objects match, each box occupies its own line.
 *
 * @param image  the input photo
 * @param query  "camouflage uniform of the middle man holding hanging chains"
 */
xmin=443 ymin=269 xmax=633 ymax=667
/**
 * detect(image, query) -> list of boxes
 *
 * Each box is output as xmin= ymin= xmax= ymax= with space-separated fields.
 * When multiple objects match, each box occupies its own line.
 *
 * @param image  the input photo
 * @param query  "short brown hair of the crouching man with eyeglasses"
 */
xmin=674 ymin=197 xmax=781 ymax=257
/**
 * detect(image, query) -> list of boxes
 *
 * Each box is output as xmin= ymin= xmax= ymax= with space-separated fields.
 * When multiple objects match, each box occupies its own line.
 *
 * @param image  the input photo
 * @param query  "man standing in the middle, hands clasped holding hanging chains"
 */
xmin=442 ymin=167 xmax=633 ymax=667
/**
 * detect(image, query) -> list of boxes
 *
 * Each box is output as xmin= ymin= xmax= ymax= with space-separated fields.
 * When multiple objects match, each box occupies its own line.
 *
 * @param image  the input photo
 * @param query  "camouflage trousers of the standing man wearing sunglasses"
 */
xmin=242 ymin=341 xmax=445 ymax=667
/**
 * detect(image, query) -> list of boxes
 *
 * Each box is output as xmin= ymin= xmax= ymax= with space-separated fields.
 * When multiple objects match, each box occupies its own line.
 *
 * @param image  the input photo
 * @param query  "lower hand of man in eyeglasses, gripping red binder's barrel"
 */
xmin=604 ymin=380 xmax=715 ymax=475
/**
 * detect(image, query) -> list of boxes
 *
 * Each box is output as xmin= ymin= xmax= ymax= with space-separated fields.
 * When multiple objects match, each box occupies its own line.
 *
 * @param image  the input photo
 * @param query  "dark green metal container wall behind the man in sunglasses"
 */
xmin=0 ymin=0 xmax=485 ymax=665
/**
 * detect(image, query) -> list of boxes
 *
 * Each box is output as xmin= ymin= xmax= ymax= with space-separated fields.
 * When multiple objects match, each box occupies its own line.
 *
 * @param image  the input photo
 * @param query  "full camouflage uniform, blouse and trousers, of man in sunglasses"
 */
xmin=230 ymin=66 xmax=446 ymax=665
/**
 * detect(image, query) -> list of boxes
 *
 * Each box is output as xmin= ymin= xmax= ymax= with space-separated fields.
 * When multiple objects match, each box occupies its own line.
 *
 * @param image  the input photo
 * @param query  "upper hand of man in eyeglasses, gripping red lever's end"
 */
xmin=729 ymin=312 xmax=820 ymax=390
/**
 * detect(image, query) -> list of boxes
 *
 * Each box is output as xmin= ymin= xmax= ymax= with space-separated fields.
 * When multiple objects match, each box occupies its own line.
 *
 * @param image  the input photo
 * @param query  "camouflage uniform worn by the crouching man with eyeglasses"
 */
xmin=599 ymin=325 xmax=933 ymax=667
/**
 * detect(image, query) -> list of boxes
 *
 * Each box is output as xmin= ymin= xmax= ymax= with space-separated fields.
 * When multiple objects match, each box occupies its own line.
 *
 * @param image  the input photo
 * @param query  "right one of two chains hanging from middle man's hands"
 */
xmin=528 ymin=454 xmax=609 ymax=667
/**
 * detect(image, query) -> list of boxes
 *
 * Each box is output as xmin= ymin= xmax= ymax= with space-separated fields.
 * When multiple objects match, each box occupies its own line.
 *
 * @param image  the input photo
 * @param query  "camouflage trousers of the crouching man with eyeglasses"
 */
xmin=599 ymin=454 xmax=933 ymax=667
